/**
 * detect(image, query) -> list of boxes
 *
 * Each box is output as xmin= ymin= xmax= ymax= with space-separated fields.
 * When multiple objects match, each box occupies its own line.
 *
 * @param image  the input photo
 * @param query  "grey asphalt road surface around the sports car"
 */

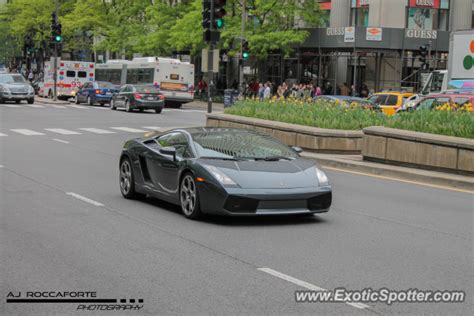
xmin=0 ymin=97 xmax=474 ymax=315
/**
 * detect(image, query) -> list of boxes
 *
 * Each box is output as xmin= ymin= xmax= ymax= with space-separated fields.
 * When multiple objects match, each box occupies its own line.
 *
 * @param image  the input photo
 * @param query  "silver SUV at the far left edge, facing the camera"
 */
xmin=0 ymin=74 xmax=35 ymax=104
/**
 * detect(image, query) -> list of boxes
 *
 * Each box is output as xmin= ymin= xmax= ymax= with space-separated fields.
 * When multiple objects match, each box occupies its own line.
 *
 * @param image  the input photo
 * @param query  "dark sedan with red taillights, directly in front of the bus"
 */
xmin=110 ymin=85 xmax=165 ymax=113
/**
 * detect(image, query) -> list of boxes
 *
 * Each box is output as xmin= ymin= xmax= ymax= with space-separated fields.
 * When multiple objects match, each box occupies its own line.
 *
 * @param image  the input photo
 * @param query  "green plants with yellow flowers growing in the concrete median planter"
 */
xmin=225 ymin=99 xmax=474 ymax=138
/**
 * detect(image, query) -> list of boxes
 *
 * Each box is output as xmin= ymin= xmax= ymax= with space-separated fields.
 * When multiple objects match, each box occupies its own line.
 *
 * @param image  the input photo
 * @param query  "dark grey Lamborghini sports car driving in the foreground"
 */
xmin=119 ymin=127 xmax=332 ymax=219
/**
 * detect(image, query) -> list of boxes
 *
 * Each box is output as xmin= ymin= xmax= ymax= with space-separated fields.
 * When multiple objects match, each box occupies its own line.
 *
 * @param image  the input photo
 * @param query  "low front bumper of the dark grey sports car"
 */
xmin=199 ymin=182 xmax=332 ymax=216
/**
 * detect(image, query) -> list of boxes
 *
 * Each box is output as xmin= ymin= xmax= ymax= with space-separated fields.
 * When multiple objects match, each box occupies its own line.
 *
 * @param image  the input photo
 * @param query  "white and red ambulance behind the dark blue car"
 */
xmin=38 ymin=59 xmax=95 ymax=99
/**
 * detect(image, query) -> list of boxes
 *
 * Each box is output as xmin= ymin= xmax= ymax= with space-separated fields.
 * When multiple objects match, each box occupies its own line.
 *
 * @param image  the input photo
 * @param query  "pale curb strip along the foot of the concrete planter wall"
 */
xmin=302 ymin=152 xmax=474 ymax=193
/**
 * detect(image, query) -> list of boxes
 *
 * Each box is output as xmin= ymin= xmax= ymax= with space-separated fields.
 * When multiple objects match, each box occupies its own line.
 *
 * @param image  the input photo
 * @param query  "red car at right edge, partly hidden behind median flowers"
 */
xmin=407 ymin=93 xmax=474 ymax=111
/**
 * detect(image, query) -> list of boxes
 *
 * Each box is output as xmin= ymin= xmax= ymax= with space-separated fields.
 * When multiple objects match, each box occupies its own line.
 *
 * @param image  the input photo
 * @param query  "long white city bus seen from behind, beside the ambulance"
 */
xmin=96 ymin=57 xmax=194 ymax=107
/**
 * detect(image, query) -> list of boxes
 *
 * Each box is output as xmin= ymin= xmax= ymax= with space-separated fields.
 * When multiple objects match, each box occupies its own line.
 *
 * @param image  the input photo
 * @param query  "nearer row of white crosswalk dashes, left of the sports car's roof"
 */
xmin=0 ymin=126 xmax=160 ymax=137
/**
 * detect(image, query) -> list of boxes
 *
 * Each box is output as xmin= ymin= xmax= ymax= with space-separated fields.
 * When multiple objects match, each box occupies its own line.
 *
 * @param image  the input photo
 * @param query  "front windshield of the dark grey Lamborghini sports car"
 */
xmin=192 ymin=130 xmax=298 ymax=159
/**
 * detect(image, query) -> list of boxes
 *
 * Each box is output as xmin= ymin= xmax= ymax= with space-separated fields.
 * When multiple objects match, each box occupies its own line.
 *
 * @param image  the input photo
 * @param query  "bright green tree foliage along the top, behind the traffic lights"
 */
xmin=0 ymin=0 xmax=321 ymax=58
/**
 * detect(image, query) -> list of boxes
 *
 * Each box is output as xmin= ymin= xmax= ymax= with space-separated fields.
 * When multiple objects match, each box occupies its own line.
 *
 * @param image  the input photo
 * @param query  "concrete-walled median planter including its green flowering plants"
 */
xmin=207 ymin=100 xmax=474 ymax=174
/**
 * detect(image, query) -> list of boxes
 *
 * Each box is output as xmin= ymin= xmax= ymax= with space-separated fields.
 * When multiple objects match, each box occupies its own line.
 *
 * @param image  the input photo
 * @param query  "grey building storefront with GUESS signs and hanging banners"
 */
xmin=260 ymin=0 xmax=474 ymax=92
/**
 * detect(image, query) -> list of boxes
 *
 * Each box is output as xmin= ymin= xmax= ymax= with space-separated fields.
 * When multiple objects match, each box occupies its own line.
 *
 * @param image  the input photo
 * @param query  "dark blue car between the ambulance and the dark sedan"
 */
xmin=74 ymin=81 xmax=118 ymax=105
